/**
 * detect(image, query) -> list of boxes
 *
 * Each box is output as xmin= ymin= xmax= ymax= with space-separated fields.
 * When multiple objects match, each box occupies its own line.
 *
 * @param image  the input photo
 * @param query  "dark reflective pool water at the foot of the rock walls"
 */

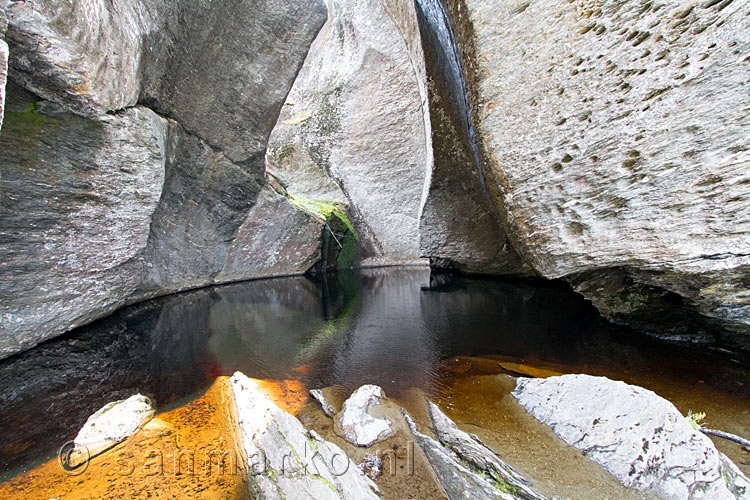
xmin=0 ymin=269 xmax=750 ymax=476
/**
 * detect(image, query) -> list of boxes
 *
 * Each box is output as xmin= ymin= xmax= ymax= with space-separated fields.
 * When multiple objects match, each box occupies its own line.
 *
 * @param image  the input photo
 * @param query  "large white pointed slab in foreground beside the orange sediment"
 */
xmin=230 ymin=372 xmax=380 ymax=500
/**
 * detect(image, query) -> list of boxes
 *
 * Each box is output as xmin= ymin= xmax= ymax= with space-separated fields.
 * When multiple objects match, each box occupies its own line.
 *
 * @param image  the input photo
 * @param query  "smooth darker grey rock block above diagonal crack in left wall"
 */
xmin=141 ymin=0 xmax=326 ymax=166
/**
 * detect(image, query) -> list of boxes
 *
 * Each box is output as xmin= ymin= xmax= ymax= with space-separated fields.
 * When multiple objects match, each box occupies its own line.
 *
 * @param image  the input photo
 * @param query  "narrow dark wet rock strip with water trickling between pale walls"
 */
xmin=412 ymin=0 xmax=531 ymax=275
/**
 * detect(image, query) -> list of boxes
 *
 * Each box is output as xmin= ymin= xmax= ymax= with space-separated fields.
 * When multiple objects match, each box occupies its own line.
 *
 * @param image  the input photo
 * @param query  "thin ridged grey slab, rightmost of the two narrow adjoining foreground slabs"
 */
xmin=427 ymin=401 xmax=546 ymax=500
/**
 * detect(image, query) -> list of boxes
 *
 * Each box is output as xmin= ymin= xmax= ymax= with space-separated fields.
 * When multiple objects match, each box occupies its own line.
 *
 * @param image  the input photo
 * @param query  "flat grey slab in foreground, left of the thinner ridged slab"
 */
xmin=404 ymin=414 xmax=518 ymax=500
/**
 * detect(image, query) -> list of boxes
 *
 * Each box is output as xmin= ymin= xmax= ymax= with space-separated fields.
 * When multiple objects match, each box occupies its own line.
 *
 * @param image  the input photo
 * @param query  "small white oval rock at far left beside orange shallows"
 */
xmin=67 ymin=394 xmax=155 ymax=467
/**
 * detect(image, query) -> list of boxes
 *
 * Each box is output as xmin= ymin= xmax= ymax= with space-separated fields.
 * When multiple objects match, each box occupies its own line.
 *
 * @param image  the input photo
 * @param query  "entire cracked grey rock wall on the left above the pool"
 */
xmin=0 ymin=0 xmax=326 ymax=357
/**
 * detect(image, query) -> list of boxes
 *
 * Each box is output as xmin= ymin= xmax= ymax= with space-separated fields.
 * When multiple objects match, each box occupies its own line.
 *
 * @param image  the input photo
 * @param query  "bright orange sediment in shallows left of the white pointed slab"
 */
xmin=0 ymin=377 xmax=244 ymax=500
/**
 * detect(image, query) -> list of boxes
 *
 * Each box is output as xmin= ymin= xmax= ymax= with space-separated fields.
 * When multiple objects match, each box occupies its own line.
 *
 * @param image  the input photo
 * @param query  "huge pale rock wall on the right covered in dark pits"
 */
xmin=463 ymin=0 xmax=750 ymax=340
